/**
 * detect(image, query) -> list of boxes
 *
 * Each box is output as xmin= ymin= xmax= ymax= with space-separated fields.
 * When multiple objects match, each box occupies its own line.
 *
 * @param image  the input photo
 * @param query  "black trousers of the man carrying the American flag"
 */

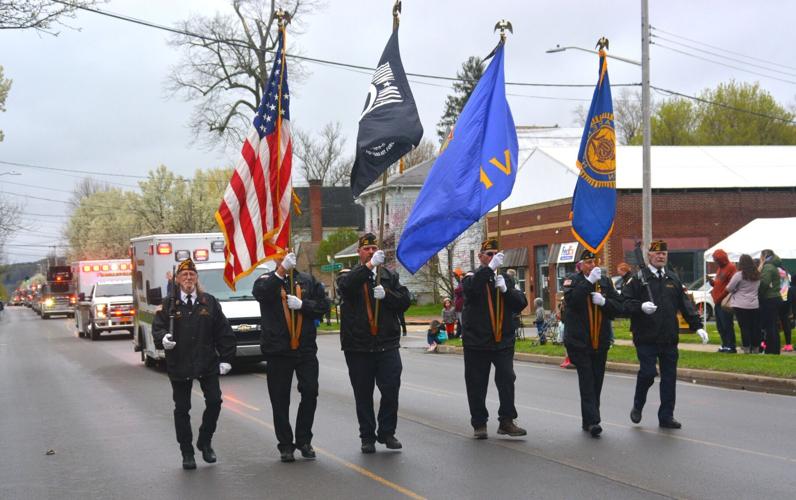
xmin=266 ymin=353 xmax=318 ymax=451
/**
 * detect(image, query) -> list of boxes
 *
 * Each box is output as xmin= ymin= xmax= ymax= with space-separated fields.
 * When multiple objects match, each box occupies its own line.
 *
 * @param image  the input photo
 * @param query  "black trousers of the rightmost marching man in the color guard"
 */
xmin=633 ymin=345 xmax=680 ymax=422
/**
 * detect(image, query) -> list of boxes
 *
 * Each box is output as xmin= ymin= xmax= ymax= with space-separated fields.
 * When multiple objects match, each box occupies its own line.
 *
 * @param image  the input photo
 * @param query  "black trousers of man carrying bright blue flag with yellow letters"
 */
xmin=464 ymin=349 xmax=517 ymax=428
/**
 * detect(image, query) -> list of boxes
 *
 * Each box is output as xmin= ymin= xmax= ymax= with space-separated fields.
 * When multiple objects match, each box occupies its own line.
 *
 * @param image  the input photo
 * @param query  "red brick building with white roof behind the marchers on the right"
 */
xmin=487 ymin=146 xmax=796 ymax=309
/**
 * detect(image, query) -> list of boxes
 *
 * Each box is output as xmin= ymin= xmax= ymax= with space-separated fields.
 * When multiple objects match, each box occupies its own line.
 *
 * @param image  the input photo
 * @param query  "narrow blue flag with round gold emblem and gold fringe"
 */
xmin=570 ymin=50 xmax=616 ymax=253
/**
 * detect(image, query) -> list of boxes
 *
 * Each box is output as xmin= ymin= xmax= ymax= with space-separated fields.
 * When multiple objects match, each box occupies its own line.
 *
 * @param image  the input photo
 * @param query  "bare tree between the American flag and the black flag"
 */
xmin=293 ymin=122 xmax=353 ymax=186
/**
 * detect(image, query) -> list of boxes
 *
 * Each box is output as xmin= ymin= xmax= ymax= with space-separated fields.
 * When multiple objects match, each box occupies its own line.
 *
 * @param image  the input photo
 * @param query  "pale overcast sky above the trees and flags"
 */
xmin=0 ymin=0 xmax=796 ymax=262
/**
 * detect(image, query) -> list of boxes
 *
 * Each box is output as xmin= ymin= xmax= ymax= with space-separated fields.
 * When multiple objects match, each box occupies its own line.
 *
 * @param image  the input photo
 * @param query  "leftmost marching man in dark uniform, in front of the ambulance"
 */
xmin=152 ymin=259 xmax=236 ymax=469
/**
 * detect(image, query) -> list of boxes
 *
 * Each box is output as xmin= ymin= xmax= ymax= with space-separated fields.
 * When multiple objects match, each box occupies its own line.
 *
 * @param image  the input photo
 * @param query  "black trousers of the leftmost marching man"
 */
xmin=171 ymin=375 xmax=222 ymax=453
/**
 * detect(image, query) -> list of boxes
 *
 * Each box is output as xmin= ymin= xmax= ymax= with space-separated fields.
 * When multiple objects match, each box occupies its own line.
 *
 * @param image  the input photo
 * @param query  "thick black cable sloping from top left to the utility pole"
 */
xmin=53 ymin=0 xmax=641 ymax=88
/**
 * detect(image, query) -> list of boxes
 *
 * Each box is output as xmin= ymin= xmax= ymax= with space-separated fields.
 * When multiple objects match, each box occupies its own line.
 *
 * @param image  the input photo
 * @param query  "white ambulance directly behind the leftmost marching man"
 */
xmin=130 ymin=233 xmax=274 ymax=366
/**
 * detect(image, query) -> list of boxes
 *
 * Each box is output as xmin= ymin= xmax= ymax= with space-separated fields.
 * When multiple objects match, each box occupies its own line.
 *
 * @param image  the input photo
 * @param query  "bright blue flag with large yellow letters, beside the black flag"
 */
xmin=398 ymin=43 xmax=518 ymax=274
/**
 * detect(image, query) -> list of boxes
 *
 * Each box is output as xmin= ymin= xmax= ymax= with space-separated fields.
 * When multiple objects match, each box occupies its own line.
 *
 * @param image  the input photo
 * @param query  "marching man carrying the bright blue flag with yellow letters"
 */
xmin=462 ymin=238 xmax=528 ymax=439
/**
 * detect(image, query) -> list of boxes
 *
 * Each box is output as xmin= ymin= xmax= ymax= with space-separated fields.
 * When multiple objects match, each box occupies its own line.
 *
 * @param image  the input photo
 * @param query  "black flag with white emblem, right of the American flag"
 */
xmin=351 ymin=29 xmax=423 ymax=197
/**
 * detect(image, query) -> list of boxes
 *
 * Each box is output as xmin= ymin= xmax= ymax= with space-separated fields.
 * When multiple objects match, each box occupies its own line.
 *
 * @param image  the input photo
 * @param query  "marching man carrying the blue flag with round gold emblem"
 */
xmin=564 ymin=250 xmax=622 ymax=437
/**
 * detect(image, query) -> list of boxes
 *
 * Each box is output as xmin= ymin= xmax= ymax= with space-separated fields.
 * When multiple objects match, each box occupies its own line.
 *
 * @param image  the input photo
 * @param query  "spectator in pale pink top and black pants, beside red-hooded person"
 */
xmin=716 ymin=254 xmax=760 ymax=353
